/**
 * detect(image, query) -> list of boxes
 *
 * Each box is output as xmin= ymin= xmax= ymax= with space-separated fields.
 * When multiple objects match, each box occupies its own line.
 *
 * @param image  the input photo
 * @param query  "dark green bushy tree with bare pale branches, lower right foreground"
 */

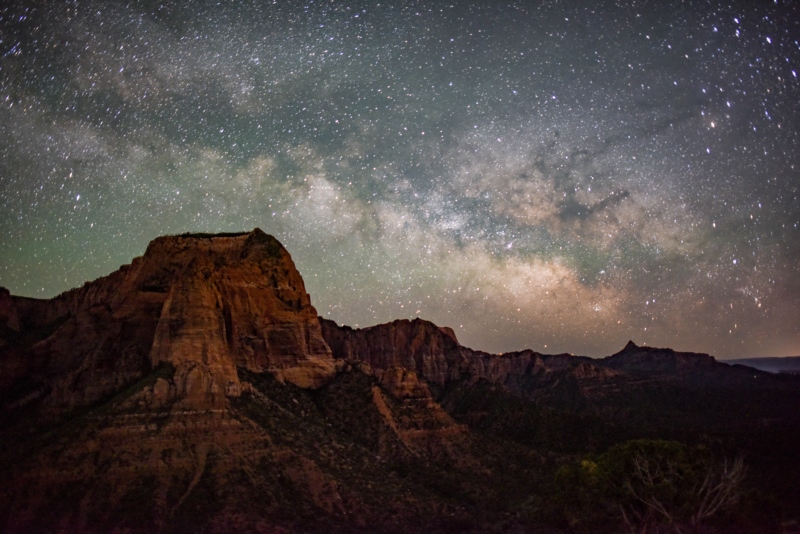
xmin=556 ymin=440 xmax=746 ymax=534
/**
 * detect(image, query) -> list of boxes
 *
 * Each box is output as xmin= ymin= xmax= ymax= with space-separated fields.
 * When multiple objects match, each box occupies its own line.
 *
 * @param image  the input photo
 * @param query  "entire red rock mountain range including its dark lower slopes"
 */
xmin=0 ymin=229 xmax=800 ymax=532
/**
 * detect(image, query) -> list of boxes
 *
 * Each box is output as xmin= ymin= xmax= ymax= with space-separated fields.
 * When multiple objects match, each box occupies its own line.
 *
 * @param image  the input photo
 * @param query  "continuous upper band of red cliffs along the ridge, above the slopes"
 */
xmin=0 ymin=229 xmax=613 ymax=412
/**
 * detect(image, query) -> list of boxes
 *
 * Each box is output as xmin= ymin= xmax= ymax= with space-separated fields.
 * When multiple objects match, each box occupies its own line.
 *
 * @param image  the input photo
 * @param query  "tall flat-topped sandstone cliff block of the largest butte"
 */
xmin=139 ymin=229 xmax=335 ymax=402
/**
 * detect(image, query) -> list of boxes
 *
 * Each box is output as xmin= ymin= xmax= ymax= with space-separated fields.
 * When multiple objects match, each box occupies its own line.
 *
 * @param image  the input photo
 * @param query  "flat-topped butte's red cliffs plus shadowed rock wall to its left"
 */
xmin=0 ymin=229 xmax=336 ymax=412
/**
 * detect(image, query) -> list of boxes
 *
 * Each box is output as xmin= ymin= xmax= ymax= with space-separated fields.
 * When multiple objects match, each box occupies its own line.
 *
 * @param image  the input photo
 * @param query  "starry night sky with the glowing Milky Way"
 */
xmin=0 ymin=0 xmax=800 ymax=358
